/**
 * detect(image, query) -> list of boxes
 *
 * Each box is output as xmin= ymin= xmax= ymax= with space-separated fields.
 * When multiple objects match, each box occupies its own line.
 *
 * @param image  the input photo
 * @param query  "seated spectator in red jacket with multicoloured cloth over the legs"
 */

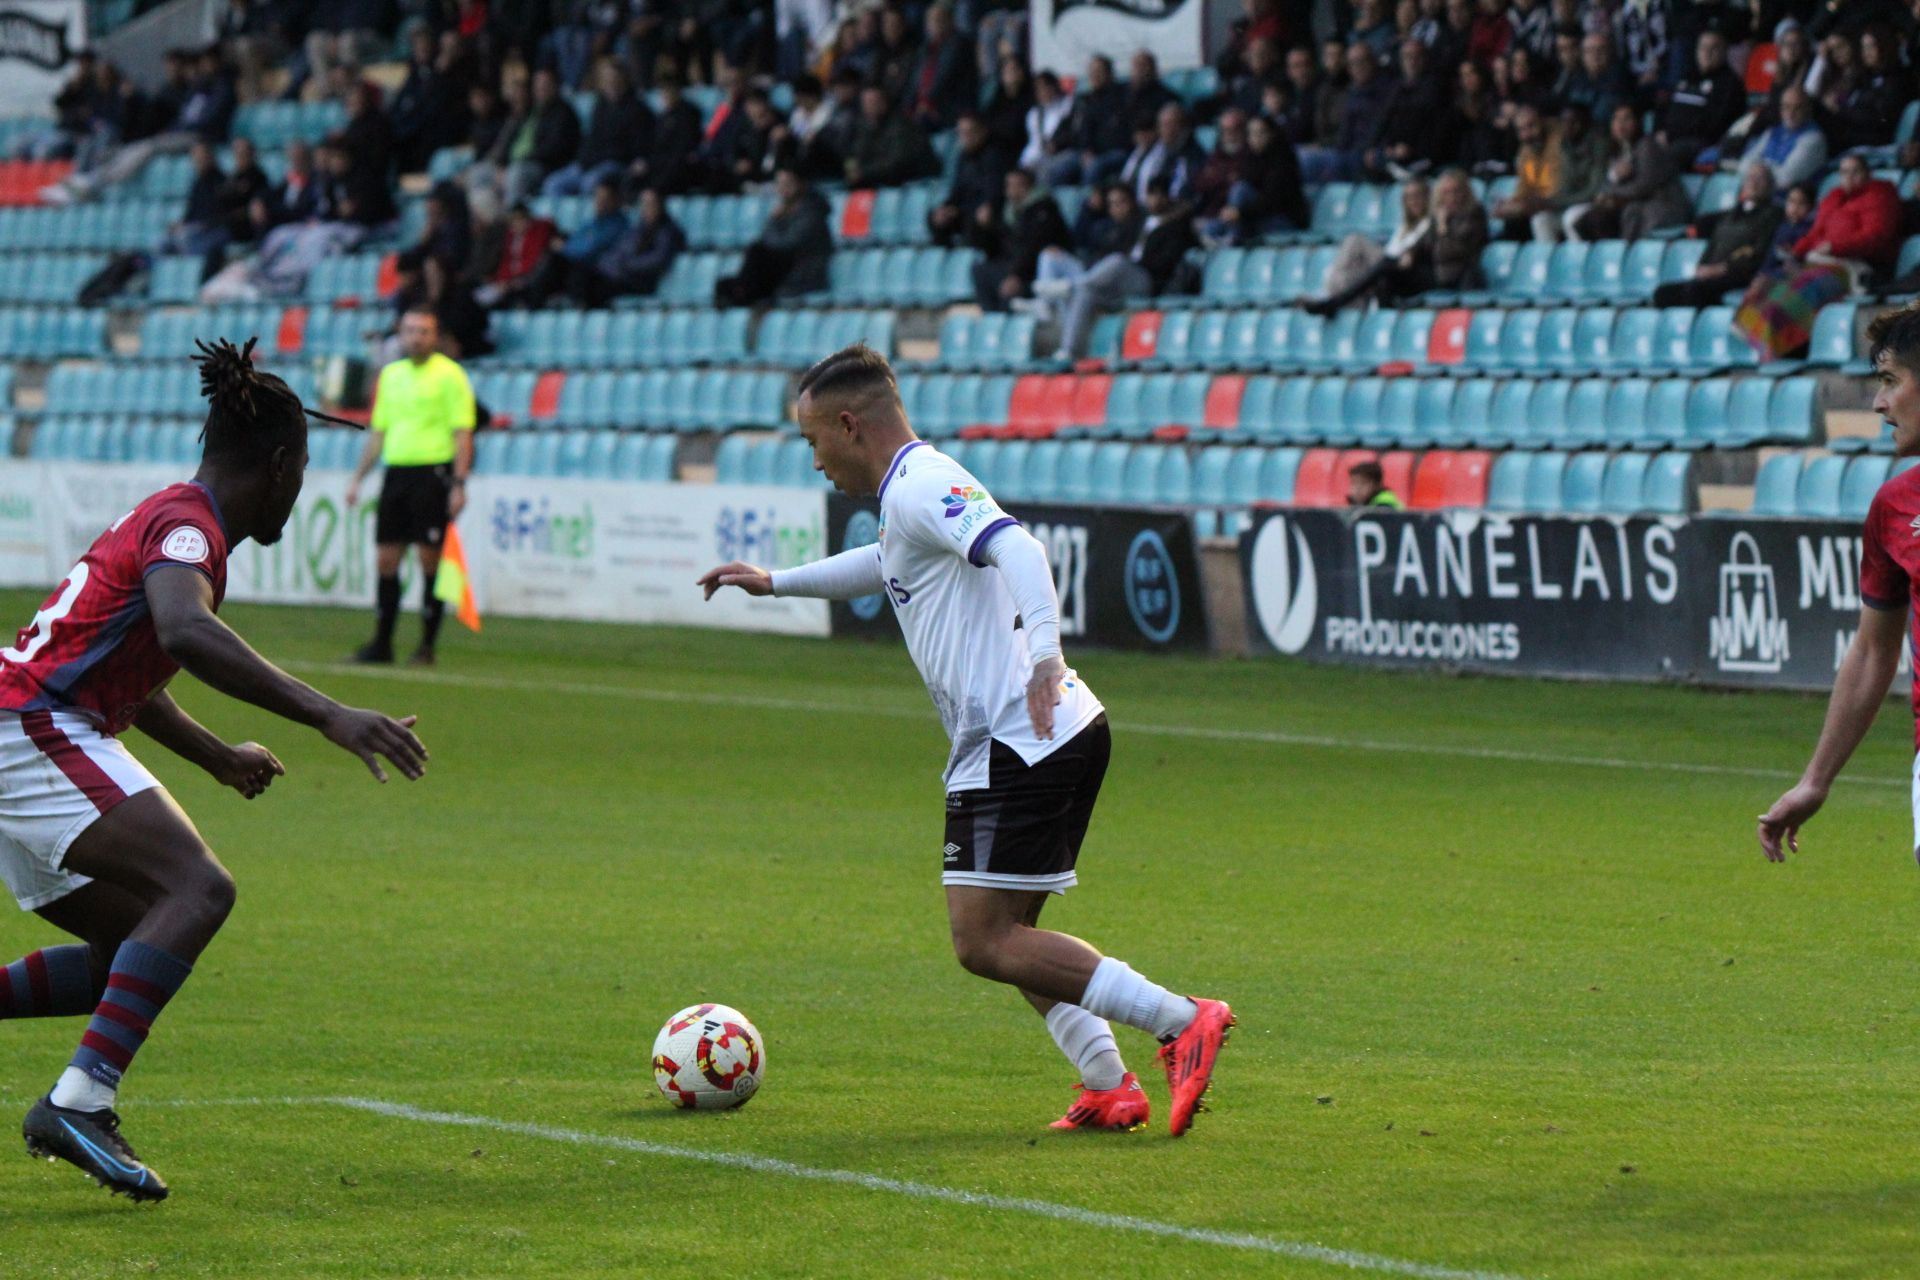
xmin=1734 ymin=155 xmax=1901 ymax=361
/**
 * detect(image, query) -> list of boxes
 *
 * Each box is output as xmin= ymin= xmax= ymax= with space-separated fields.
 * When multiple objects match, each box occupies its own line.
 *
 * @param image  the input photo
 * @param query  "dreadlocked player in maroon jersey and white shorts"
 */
xmin=0 ymin=342 xmax=426 ymax=1199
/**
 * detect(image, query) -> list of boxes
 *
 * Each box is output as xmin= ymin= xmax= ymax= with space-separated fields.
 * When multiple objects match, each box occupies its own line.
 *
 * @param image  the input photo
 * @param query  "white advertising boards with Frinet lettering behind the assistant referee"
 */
xmin=0 ymin=462 xmax=828 ymax=635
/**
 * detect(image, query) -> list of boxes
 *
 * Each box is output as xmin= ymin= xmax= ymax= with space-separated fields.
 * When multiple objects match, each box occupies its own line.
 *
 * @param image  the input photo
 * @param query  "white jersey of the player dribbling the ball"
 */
xmin=879 ymin=441 xmax=1102 ymax=791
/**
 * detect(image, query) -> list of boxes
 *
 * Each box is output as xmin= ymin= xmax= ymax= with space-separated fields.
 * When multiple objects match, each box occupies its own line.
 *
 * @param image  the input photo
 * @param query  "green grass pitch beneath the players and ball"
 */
xmin=0 ymin=593 xmax=1920 ymax=1280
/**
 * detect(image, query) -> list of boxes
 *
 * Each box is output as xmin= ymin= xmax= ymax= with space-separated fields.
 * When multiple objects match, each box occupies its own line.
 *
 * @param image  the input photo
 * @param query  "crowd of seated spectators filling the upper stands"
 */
xmin=23 ymin=0 xmax=1920 ymax=357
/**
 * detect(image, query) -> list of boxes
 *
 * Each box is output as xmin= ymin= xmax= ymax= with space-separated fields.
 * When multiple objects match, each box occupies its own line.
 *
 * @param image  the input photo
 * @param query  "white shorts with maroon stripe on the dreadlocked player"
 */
xmin=0 ymin=712 xmax=159 ymax=912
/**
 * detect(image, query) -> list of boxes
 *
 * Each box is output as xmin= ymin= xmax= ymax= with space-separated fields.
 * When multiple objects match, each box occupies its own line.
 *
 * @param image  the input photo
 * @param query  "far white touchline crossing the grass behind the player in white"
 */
xmin=282 ymin=662 xmax=1912 ymax=791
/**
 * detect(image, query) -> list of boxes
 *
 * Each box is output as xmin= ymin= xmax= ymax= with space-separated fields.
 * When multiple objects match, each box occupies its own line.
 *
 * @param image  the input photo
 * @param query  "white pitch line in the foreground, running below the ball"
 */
xmin=116 ymin=1098 xmax=1521 ymax=1280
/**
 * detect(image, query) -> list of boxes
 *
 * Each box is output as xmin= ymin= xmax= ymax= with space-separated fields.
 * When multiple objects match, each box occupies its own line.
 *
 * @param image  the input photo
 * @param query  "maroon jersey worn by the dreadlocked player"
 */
xmin=0 ymin=484 xmax=227 ymax=733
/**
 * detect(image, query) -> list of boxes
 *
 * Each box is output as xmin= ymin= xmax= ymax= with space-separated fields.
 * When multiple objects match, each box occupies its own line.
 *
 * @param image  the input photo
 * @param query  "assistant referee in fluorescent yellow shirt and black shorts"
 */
xmin=348 ymin=311 xmax=474 ymax=666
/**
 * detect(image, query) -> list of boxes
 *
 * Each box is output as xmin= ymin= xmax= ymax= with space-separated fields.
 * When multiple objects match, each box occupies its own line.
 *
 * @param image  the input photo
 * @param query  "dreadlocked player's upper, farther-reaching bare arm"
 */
xmin=146 ymin=564 xmax=426 ymax=783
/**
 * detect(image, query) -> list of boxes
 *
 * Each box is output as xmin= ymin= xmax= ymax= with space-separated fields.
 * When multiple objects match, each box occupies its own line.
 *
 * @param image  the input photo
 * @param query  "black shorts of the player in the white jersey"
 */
xmin=941 ymin=714 xmax=1114 ymax=892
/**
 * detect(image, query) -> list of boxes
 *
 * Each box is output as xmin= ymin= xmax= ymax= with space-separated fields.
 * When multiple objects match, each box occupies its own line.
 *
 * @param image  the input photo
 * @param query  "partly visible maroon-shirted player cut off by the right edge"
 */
xmin=1761 ymin=303 xmax=1920 ymax=862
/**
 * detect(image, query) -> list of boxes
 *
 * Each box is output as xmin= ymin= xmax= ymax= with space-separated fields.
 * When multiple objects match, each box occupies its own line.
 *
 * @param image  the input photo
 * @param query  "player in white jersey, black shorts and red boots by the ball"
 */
xmin=701 ymin=344 xmax=1235 ymax=1136
